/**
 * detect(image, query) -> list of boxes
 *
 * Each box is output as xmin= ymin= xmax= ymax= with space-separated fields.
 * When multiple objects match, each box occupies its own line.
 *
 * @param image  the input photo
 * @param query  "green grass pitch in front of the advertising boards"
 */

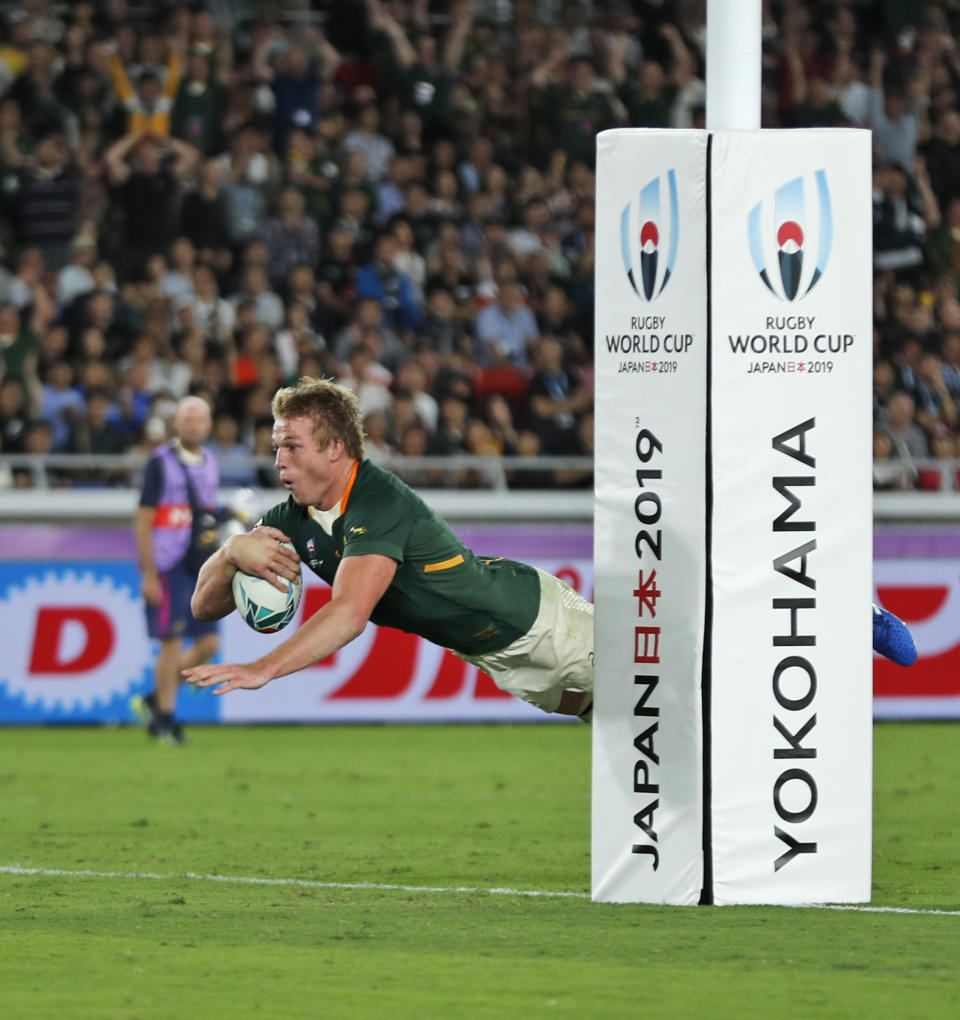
xmin=0 ymin=724 xmax=960 ymax=1020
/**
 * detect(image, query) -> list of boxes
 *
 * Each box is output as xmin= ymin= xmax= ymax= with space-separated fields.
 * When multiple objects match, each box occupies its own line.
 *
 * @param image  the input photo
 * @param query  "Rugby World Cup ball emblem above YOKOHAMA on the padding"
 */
xmin=747 ymin=170 xmax=833 ymax=301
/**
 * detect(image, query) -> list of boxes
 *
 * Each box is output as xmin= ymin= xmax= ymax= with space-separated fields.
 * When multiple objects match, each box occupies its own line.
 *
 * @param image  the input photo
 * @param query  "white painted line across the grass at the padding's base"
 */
xmin=0 ymin=864 xmax=960 ymax=917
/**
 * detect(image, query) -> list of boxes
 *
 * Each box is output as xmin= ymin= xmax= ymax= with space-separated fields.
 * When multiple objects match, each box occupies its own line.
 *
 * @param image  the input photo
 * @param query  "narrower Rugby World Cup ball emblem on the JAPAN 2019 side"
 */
xmin=620 ymin=170 xmax=679 ymax=301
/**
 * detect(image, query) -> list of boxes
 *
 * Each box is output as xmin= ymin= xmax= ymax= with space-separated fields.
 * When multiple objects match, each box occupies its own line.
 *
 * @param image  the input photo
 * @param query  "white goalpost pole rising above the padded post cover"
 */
xmin=707 ymin=0 xmax=762 ymax=131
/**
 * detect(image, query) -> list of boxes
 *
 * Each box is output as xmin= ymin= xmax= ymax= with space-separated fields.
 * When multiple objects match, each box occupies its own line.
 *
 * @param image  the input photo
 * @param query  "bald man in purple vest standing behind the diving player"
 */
xmin=134 ymin=397 xmax=219 ymax=744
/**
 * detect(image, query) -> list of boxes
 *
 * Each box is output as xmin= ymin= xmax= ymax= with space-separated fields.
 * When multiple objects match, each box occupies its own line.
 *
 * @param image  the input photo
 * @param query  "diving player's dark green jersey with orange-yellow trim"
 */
xmin=263 ymin=460 xmax=540 ymax=655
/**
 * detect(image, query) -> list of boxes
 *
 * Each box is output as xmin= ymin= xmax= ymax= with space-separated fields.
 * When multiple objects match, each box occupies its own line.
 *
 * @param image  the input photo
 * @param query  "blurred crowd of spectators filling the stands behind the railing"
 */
xmin=0 ymin=0 xmax=960 ymax=489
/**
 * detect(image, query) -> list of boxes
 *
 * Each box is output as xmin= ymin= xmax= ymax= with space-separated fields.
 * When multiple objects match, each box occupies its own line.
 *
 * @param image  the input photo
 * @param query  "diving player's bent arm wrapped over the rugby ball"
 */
xmin=190 ymin=527 xmax=300 ymax=620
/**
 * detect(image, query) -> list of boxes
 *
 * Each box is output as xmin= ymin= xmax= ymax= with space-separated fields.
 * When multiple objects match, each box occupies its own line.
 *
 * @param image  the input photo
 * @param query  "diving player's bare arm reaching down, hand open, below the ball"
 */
xmin=184 ymin=554 xmax=397 ymax=695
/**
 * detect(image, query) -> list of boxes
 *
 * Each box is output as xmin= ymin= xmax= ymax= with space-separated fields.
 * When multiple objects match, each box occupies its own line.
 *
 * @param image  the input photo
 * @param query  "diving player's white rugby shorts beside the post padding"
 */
xmin=454 ymin=568 xmax=594 ymax=712
